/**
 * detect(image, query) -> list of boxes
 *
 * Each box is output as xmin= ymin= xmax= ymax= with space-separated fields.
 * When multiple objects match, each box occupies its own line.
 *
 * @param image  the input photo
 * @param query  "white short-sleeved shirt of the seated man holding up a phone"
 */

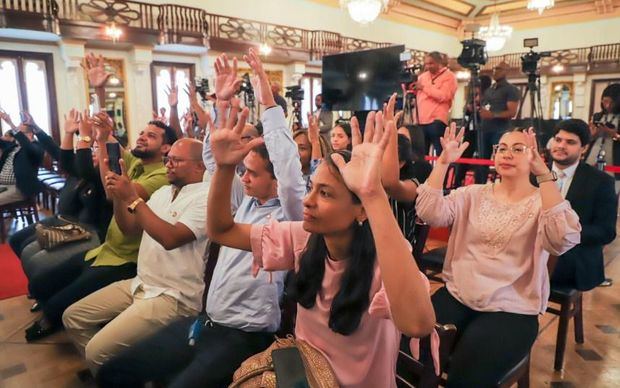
xmin=131 ymin=181 xmax=209 ymax=311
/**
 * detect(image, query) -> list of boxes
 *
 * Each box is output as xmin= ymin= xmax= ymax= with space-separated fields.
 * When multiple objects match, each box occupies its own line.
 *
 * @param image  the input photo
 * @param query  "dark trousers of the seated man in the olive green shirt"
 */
xmin=29 ymin=253 xmax=136 ymax=326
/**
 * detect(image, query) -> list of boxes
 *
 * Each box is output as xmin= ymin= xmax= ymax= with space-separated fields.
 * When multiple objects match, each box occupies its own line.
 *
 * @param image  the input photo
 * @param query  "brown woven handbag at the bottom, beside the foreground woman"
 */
xmin=229 ymin=335 xmax=338 ymax=388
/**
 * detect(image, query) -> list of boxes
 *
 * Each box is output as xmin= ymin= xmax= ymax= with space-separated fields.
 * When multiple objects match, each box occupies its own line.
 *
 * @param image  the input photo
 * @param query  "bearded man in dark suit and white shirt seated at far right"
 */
xmin=551 ymin=119 xmax=617 ymax=291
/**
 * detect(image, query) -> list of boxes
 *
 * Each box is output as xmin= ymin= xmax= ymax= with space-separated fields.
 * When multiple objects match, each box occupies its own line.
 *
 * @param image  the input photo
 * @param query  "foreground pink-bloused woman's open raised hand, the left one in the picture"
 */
xmin=209 ymin=108 xmax=264 ymax=167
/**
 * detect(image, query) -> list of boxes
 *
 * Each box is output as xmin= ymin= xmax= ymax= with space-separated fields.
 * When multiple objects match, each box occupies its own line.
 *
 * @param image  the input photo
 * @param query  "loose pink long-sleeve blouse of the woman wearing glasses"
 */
xmin=416 ymin=183 xmax=581 ymax=315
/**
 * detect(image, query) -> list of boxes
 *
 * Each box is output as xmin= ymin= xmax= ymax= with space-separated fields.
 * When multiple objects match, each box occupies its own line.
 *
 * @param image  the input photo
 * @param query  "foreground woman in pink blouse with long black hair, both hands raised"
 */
xmin=207 ymin=104 xmax=435 ymax=388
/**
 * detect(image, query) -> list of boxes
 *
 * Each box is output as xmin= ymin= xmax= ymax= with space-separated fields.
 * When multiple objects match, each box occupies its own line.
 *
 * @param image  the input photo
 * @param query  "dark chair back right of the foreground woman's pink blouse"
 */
xmin=396 ymin=324 xmax=456 ymax=388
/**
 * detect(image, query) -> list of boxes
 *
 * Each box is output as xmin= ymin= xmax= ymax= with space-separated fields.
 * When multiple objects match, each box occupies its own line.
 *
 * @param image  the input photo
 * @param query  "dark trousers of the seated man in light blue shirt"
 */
xmin=97 ymin=317 xmax=274 ymax=388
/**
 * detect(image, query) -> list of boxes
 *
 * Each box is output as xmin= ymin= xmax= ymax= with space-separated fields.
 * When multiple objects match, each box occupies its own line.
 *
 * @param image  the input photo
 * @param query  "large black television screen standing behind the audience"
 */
xmin=322 ymin=45 xmax=405 ymax=111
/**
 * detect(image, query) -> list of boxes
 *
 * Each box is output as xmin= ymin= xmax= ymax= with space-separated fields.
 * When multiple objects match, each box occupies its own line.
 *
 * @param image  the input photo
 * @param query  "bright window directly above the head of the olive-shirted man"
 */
xmin=151 ymin=62 xmax=194 ymax=118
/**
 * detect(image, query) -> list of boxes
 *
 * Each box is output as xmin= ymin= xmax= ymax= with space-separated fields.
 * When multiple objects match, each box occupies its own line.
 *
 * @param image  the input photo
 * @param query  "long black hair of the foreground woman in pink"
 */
xmin=292 ymin=151 xmax=377 ymax=335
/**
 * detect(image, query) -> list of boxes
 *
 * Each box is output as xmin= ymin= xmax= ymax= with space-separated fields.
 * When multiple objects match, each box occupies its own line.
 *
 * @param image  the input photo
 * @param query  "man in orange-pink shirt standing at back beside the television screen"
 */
xmin=415 ymin=51 xmax=457 ymax=155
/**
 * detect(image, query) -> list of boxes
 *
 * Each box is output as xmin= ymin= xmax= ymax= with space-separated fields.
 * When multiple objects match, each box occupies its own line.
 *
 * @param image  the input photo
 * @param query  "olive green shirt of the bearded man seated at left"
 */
xmin=85 ymin=151 xmax=169 ymax=266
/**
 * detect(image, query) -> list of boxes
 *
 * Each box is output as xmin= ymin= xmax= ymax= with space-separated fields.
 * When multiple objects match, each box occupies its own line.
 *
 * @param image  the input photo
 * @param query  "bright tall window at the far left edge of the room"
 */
xmin=0 ymin=50 xmax=60 ymax=141
